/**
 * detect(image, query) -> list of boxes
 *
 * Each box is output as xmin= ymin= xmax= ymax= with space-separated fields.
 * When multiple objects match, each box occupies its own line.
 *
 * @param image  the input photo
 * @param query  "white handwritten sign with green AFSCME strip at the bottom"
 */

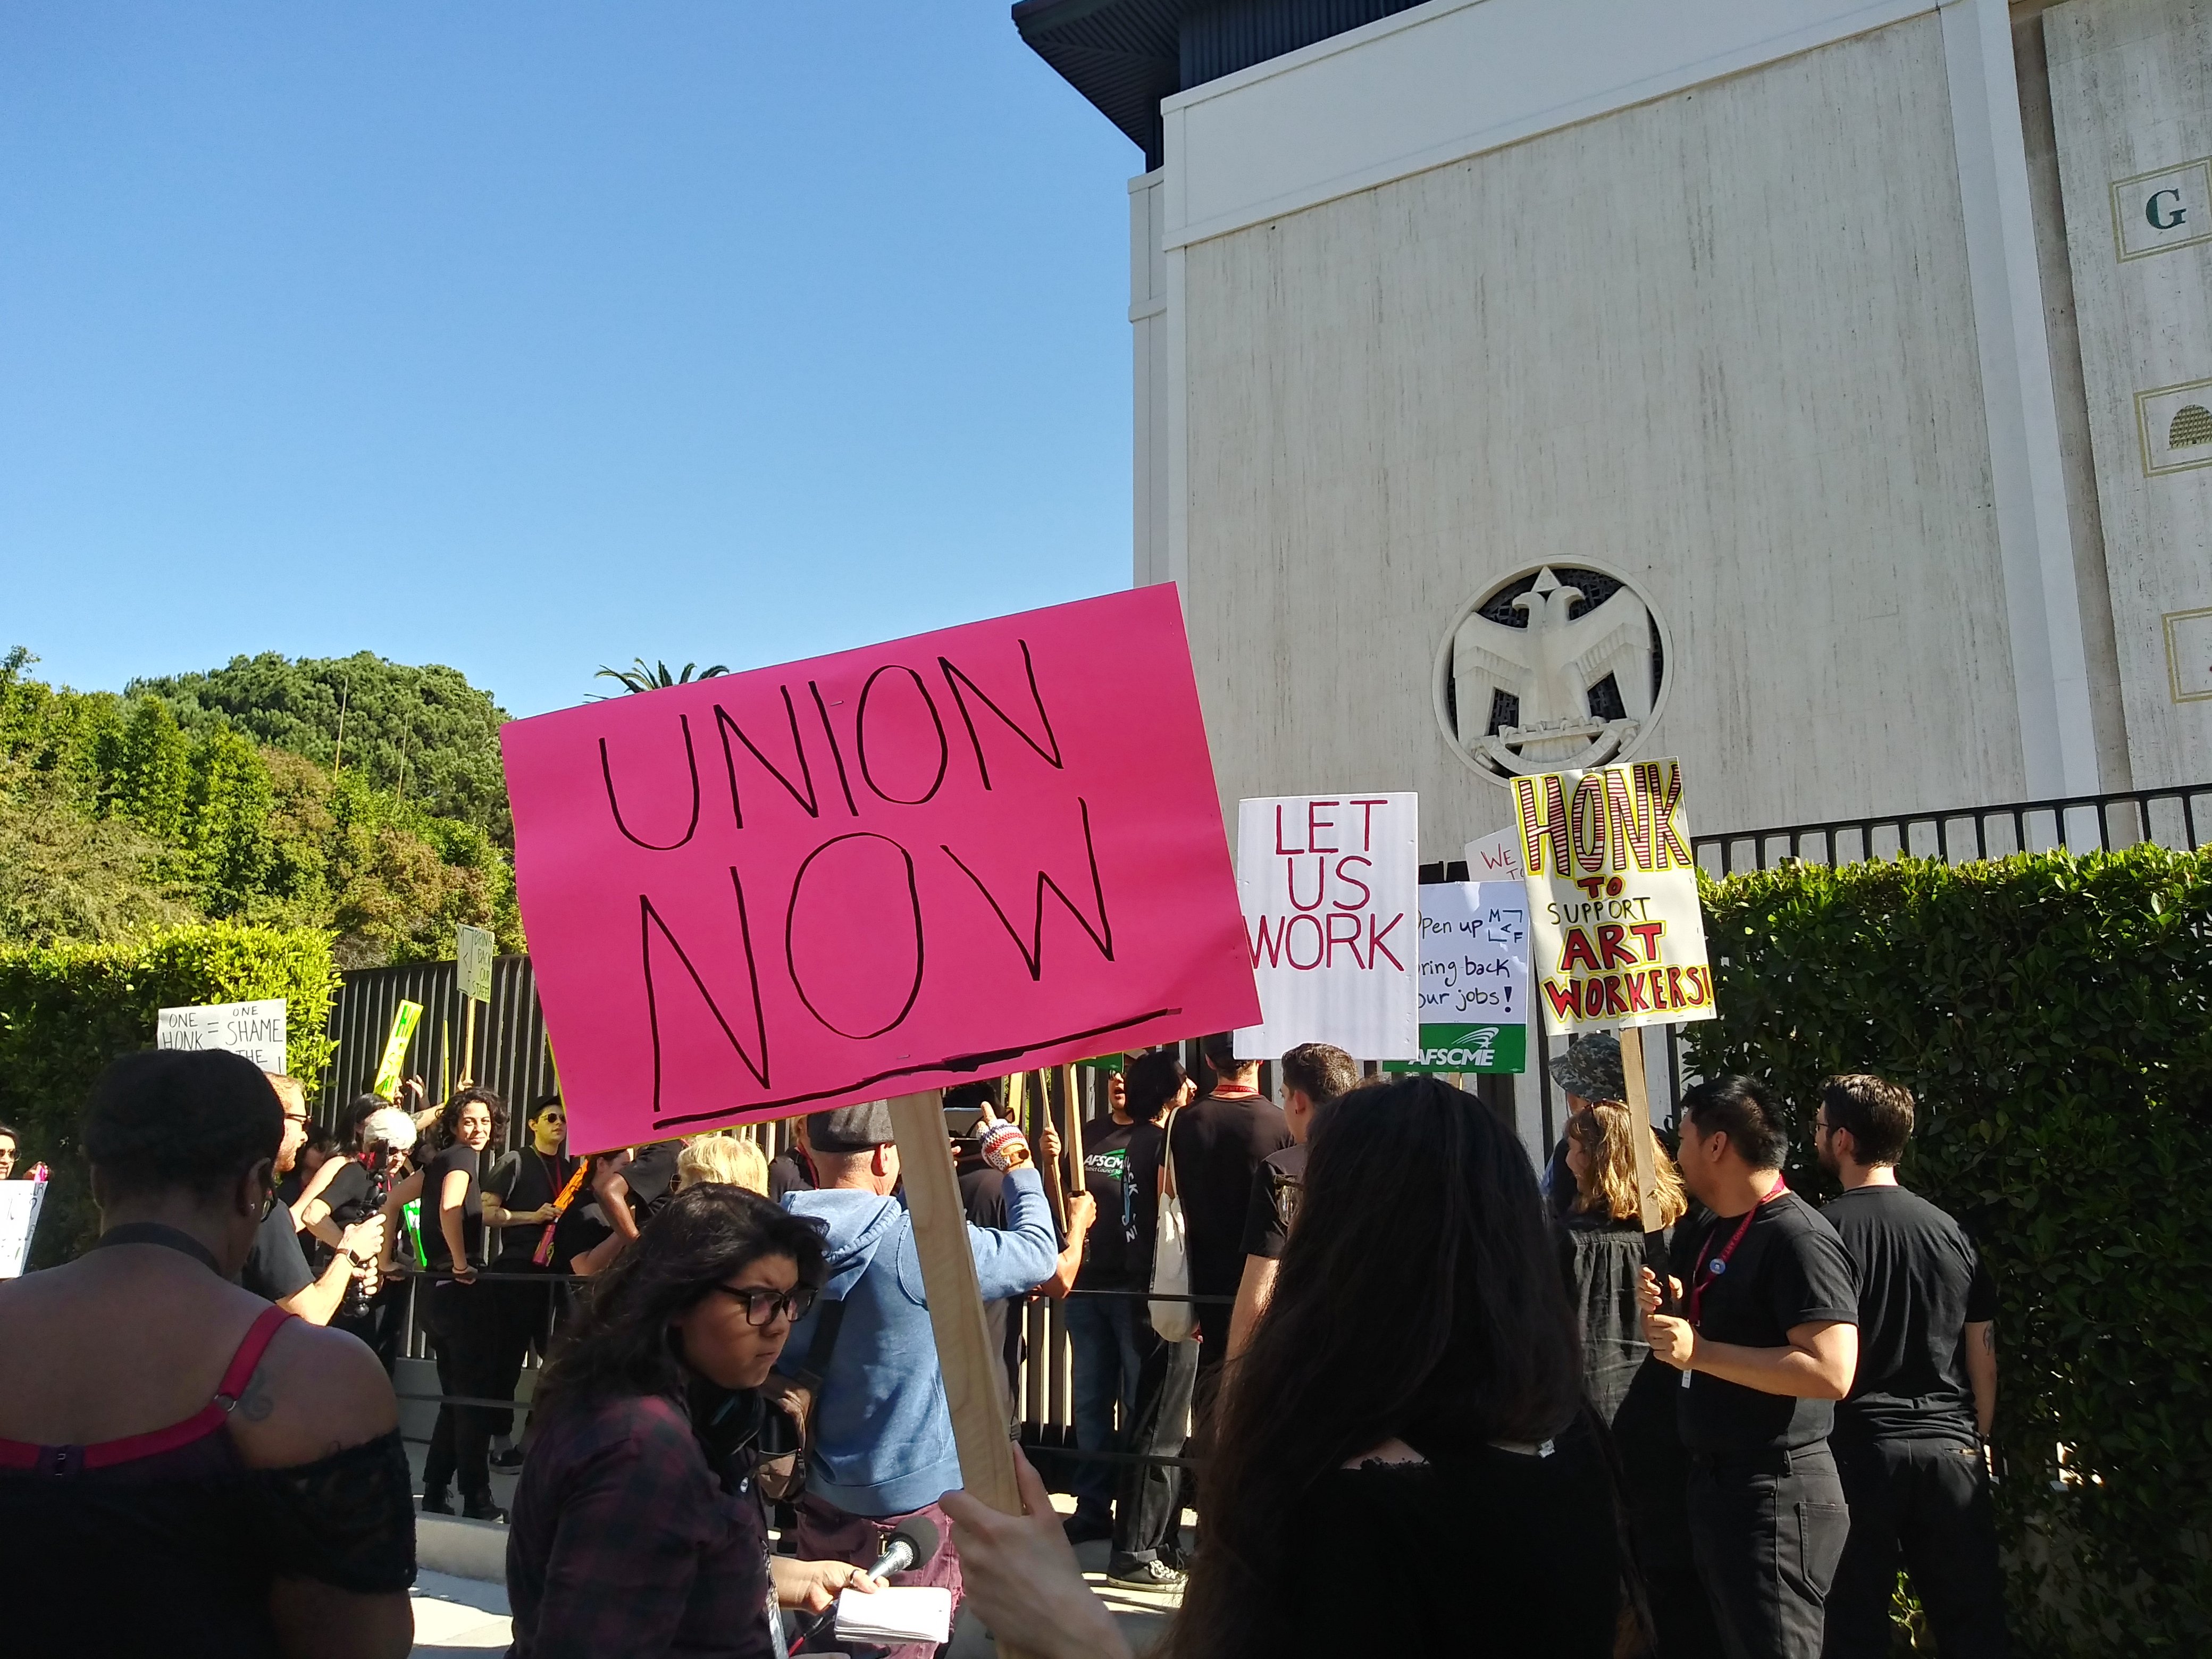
xmin=1382 ymin=881 xmax=1529 ymax=1073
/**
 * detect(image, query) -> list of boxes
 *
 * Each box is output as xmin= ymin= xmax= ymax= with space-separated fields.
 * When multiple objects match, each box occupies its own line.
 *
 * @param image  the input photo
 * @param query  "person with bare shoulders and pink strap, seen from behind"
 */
xmin=0 ymin=1051 xmax=414 ymax=1659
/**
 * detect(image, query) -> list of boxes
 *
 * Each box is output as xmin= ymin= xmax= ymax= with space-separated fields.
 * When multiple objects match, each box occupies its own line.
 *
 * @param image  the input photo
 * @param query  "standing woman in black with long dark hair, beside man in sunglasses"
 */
xmin=385 ymin=1088 xmax=507 ymax=1520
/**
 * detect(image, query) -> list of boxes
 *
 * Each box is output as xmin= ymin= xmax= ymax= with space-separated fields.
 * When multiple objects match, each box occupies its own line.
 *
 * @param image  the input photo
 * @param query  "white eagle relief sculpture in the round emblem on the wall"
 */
xmin=1449 ymin=566 xmax=1657 ymax=776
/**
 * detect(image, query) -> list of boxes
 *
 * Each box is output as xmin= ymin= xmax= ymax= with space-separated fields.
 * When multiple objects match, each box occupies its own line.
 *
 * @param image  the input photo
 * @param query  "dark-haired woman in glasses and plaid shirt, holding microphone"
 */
xmin=507 ymin=1186 xmax=876 ymax=1659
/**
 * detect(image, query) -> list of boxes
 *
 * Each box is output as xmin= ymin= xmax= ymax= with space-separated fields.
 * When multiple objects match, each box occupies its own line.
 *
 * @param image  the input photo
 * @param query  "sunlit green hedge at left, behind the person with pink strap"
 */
xmin=0 ymin=923 xmax=338 ymax=1266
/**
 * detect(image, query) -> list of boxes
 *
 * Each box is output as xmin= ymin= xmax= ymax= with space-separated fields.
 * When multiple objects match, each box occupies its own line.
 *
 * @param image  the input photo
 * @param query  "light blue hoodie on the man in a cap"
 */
xmin=783 ymin=1170 xmax=1060 ymax=1515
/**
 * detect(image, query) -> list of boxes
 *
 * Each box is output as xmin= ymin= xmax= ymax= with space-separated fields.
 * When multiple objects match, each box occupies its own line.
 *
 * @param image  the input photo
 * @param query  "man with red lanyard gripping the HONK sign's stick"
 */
xmin=1644 ymin=1077 xmax=1858 ymax=1659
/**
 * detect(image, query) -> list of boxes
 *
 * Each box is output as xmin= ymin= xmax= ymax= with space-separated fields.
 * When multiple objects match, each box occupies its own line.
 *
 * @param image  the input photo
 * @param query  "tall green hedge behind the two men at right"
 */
xmin=1686 ymin=847 xmax=2212 ymax=1655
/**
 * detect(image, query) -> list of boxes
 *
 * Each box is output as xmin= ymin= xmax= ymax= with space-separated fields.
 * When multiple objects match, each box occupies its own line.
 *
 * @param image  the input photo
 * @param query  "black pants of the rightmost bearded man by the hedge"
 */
xmin=1827 ymin=1440 xmax=2004 ymax=1659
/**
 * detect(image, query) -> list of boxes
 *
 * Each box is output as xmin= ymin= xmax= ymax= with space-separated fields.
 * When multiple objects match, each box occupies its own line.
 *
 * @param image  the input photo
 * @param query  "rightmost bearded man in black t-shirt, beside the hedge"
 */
xmin=1814 ymin=1075 xmax=2004 ymax=1659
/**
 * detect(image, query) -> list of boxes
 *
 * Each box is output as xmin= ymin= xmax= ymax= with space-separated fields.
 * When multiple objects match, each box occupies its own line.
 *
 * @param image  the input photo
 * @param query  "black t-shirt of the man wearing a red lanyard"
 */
xmin=1677 ymin=1192 xmax=1858 ymax=1451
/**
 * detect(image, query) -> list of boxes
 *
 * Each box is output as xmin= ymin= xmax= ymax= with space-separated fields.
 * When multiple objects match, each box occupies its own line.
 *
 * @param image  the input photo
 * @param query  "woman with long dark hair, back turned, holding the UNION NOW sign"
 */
xmin=944 ymin=1077 xmax=1626 ymax=1659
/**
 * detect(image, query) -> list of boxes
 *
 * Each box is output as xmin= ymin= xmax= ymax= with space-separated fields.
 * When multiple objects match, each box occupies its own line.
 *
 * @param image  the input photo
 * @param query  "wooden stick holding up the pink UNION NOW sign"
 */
xmin=891 ymin=1088 xmax=1022 ymax=1659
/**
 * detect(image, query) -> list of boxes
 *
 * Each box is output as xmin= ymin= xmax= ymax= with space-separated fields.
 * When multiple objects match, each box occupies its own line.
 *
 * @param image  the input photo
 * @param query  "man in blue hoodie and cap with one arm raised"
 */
xmin=783 ymin=1102 xmax=1060 ymax=1659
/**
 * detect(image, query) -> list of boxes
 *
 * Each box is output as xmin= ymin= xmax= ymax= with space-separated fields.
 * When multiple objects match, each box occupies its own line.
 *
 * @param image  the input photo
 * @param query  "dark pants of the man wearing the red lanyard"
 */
xmin=1690 ymin=1440 xmax=1849 ymax=1659
